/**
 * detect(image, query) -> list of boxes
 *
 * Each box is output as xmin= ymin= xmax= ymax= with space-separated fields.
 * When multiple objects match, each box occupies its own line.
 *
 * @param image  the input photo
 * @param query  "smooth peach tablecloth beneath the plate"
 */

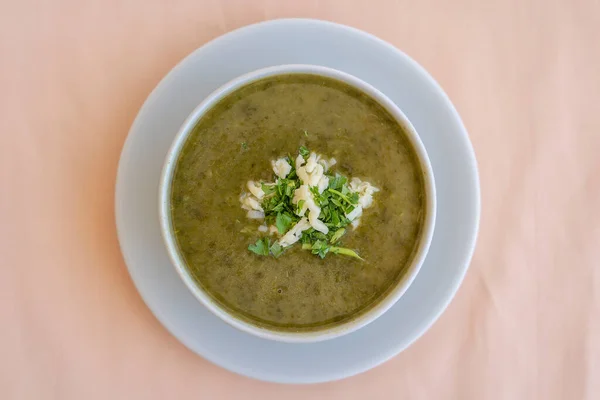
xmin=0 ymin=0 xmax=600 ymax=400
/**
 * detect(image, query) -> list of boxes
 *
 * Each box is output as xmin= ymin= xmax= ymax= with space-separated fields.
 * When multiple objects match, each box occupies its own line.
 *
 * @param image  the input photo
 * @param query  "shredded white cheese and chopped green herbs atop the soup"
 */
xmin=240 ymin=146 xmax=379 ymax=260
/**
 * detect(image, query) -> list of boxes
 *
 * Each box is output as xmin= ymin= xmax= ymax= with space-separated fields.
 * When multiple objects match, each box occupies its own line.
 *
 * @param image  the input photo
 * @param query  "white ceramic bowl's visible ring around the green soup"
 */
xmin=159 ymin=64 xmax=436 ymax=343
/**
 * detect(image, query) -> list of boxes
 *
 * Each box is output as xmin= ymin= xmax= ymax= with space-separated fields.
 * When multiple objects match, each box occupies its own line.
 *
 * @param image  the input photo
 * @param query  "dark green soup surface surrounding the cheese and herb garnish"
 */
xmin=171 ymin=74 xmax=425 ymax=331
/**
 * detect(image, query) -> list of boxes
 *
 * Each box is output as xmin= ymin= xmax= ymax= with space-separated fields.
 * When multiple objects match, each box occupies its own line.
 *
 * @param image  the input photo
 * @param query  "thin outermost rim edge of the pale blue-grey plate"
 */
xmin=115 ymin=18 xmax=481 ymax=384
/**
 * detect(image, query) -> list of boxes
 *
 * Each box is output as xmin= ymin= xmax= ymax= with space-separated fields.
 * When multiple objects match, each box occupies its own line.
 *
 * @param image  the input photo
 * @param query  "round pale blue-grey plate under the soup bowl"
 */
xmin=116 ymin=19 xmax=480 ymax=383
